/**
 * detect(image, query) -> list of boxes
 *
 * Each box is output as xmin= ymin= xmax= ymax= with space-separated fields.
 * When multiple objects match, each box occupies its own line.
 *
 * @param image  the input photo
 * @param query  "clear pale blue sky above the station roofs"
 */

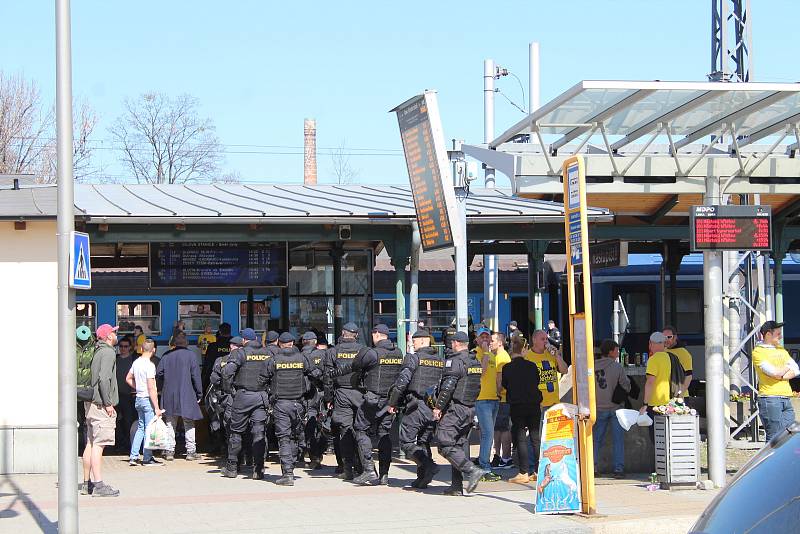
xmin=0 ymin=0 xmax=800 ymax=186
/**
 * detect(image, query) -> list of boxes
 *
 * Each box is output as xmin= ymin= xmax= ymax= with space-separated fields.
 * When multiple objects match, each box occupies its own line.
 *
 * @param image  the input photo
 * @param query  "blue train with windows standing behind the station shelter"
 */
xmin=76 ymin=255 xmax=800 ymax=376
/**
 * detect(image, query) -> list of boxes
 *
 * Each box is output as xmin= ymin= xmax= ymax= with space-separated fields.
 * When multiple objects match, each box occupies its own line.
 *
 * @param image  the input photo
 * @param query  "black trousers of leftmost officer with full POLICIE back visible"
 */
xmin=228 ymin=390 xmax=267 ymax=471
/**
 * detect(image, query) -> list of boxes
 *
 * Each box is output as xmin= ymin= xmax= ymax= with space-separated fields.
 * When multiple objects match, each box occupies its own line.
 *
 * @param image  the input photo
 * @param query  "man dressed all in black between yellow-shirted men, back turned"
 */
xmin=497 ymin=336 xmax=542 ymax=484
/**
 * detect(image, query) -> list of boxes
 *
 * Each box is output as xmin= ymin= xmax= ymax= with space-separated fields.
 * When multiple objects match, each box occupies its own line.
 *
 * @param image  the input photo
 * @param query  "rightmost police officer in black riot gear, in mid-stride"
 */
xmin=433 ymin=332 xmax=486 ymax=495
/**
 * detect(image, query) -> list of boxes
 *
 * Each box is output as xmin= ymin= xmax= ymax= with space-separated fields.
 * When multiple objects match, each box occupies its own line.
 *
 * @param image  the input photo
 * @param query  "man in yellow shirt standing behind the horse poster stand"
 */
xmin=525 ymin=330 xmax=568 ymax=474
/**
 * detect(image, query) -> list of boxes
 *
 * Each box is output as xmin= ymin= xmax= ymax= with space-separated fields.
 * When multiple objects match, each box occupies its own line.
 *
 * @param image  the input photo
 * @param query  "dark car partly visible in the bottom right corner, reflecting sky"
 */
xmin=690 ymin=423 xmax=800 ymax=534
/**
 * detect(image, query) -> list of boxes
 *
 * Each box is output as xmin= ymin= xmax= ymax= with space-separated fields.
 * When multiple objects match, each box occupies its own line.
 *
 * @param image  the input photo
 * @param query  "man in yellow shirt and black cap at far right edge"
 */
xmin=751 ymin=321 xmax=800 ymax=442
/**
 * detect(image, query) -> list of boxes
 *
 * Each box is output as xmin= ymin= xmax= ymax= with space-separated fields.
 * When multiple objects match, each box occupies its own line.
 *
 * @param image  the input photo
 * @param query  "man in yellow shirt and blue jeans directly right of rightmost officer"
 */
xmin=475 ymin=328 xmax=511 ymax=482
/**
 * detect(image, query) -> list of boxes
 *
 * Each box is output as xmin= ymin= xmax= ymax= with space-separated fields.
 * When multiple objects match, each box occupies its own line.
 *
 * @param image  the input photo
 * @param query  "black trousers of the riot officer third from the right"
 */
xmin=353 ymin=391 xmax=394 ymax=476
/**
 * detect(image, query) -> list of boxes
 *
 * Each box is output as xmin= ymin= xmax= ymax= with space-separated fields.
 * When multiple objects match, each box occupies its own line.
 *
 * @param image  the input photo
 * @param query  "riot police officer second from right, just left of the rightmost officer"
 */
xmin=389 ymin=329 xmax=444 ymax=489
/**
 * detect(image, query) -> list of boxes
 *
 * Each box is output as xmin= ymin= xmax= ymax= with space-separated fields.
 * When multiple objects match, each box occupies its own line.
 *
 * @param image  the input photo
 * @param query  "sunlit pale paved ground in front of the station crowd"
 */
xmin=0 ymin=456 xmax=716 ymax=534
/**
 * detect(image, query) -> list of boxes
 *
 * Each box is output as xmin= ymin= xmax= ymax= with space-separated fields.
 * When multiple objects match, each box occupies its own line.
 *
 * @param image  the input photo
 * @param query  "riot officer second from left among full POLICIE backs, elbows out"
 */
xmin=259 ymin=332 xmax=320 ymax=486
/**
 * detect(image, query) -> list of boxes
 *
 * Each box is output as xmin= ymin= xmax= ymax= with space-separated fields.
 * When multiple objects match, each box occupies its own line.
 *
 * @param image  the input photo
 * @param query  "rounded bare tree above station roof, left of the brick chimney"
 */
xmin=109 ymin=93 xmax=220 ymax=184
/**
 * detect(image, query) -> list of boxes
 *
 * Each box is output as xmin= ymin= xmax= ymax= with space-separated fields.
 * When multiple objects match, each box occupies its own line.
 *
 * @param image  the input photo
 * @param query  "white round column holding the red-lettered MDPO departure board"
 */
xmin=703 ymin=176 xmax=728 ymax=487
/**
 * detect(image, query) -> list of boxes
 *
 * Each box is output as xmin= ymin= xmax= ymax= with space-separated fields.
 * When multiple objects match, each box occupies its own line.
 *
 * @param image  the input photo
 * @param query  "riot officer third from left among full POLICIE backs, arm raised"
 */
xmin=324 ymin=323 xmax=375 ymax=480
